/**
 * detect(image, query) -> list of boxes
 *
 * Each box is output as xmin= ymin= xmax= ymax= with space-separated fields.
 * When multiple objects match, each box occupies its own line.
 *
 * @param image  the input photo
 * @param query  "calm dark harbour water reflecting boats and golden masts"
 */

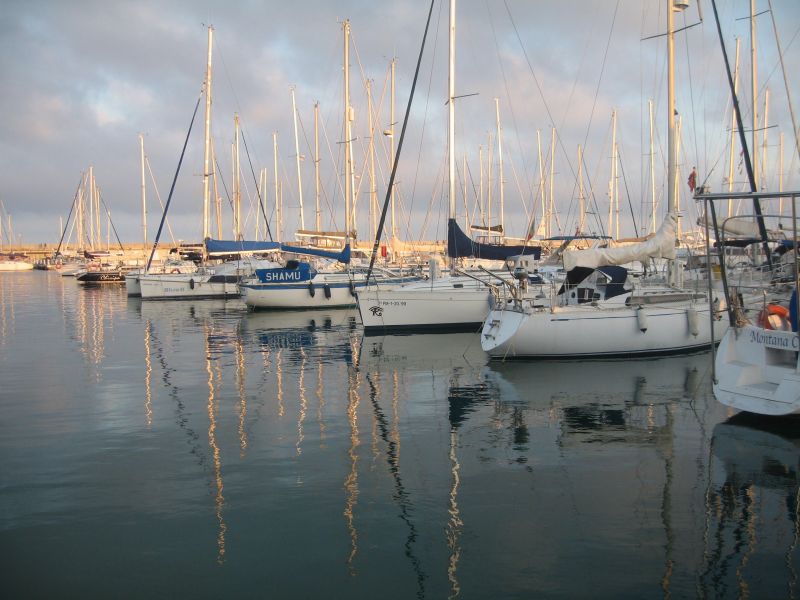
xmin=0 ymin=271 xmax=800 ymax=599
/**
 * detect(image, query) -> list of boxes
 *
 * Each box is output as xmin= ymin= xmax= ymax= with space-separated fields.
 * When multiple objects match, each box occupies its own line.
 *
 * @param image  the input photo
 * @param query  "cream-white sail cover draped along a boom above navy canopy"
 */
xmin=564 ymin=212 xmax=678 ymax=271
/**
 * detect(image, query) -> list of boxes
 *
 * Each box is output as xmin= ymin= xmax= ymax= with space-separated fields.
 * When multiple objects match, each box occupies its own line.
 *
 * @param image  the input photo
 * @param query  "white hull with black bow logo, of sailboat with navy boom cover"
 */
xmin=358 ymin=277 xmax=490 ymax=334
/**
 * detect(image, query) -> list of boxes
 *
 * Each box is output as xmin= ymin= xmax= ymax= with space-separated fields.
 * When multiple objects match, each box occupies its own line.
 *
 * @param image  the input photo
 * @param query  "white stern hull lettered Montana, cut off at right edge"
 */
xmin=714 ymin=324 xmax=800 ymax=416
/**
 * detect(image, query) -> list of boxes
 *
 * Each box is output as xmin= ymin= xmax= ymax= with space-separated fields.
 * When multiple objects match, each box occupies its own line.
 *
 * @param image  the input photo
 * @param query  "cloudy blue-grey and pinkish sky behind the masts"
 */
xmin=0 ymin=0 xmax=800 ymax=245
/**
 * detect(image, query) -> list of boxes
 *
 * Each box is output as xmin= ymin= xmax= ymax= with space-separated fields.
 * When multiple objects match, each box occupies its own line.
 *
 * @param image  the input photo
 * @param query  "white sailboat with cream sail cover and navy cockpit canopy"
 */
xmin=481 ymin=0 xmax=727 ymax=358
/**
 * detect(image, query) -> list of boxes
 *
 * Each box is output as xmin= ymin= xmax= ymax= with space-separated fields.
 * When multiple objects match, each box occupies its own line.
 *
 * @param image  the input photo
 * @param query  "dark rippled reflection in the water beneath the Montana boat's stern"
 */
xmin=699 ymin=413 xmax=800 ymax=598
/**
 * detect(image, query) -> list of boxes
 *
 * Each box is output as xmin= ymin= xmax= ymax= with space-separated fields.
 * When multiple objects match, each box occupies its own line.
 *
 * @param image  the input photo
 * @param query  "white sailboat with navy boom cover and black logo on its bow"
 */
xmin=357 ymin=0 xmax=541 ymax=334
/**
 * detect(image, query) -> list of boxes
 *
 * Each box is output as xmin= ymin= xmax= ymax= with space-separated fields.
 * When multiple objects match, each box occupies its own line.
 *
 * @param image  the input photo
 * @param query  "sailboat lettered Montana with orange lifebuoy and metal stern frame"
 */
xmin=695 ymin=4 xmax=800 ymax=416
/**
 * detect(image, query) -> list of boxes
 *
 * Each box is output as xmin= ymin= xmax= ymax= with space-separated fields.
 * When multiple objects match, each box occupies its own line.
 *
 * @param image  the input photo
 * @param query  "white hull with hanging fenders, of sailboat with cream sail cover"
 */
xmin=481 ymin=294 xmax=727 ymax=358
